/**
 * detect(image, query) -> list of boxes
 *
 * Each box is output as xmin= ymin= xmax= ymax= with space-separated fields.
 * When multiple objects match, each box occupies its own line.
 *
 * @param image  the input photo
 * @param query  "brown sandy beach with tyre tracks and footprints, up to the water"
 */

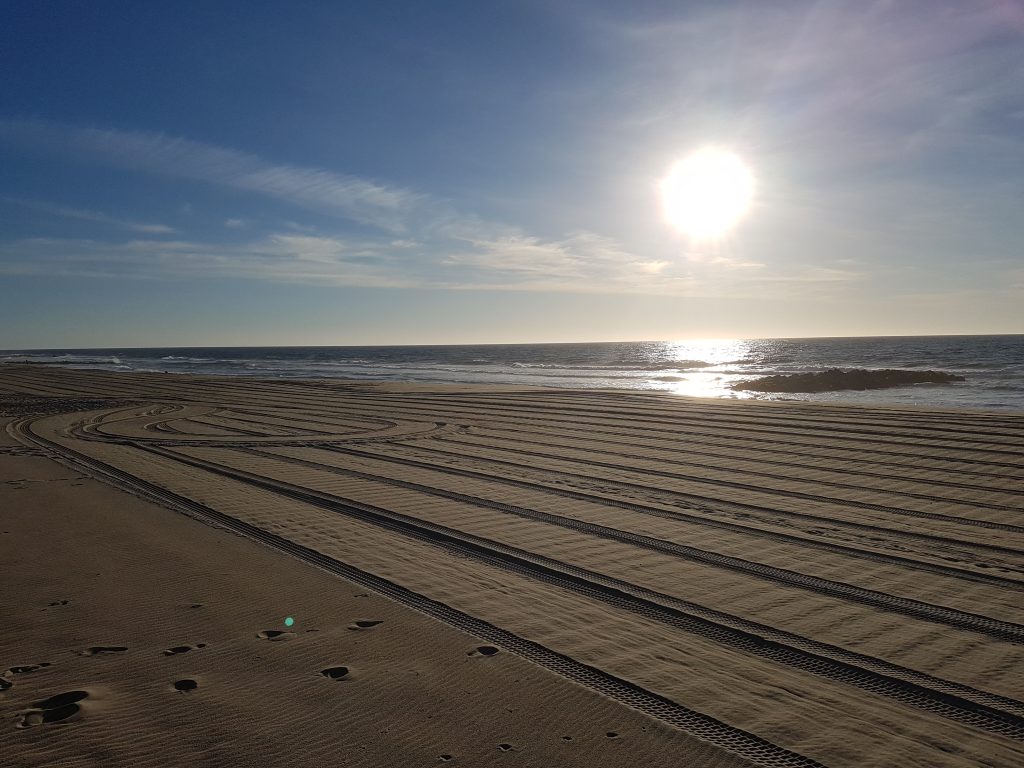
xmin=0 ymin=366 xmax=1024 ymax=767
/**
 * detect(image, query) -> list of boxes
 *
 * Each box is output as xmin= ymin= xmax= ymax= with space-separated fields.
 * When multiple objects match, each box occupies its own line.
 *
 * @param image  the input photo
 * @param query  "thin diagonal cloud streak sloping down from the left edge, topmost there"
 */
xmin=0 ymin=120 xmax=422 ymax=231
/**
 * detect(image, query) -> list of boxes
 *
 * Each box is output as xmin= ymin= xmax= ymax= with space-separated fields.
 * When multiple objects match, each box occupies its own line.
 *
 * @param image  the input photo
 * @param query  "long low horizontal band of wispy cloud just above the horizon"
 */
xmin=0 ymin=231 xmax=863 ymax=297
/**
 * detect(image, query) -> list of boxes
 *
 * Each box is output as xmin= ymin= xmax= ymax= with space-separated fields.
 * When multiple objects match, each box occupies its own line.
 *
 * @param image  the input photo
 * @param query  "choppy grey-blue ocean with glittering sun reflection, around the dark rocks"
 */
xmin=0 ymin=335 xmax=1024 ymax=411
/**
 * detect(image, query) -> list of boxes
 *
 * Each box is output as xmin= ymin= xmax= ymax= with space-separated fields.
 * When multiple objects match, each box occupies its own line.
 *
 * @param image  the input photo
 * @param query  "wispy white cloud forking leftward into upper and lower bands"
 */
xmin=0 ymin=120 xmax=880 ymax=296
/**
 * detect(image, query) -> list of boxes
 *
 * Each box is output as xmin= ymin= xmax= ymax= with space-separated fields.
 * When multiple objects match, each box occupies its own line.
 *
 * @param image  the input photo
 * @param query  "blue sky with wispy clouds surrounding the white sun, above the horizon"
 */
xmin=0 ymin=0 xmax=1024 ymax=349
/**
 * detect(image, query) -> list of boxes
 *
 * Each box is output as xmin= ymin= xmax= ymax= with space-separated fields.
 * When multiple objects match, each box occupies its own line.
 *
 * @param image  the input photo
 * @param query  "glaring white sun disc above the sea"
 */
xmin=660 ymin=147 xmax=754 ymax=240
